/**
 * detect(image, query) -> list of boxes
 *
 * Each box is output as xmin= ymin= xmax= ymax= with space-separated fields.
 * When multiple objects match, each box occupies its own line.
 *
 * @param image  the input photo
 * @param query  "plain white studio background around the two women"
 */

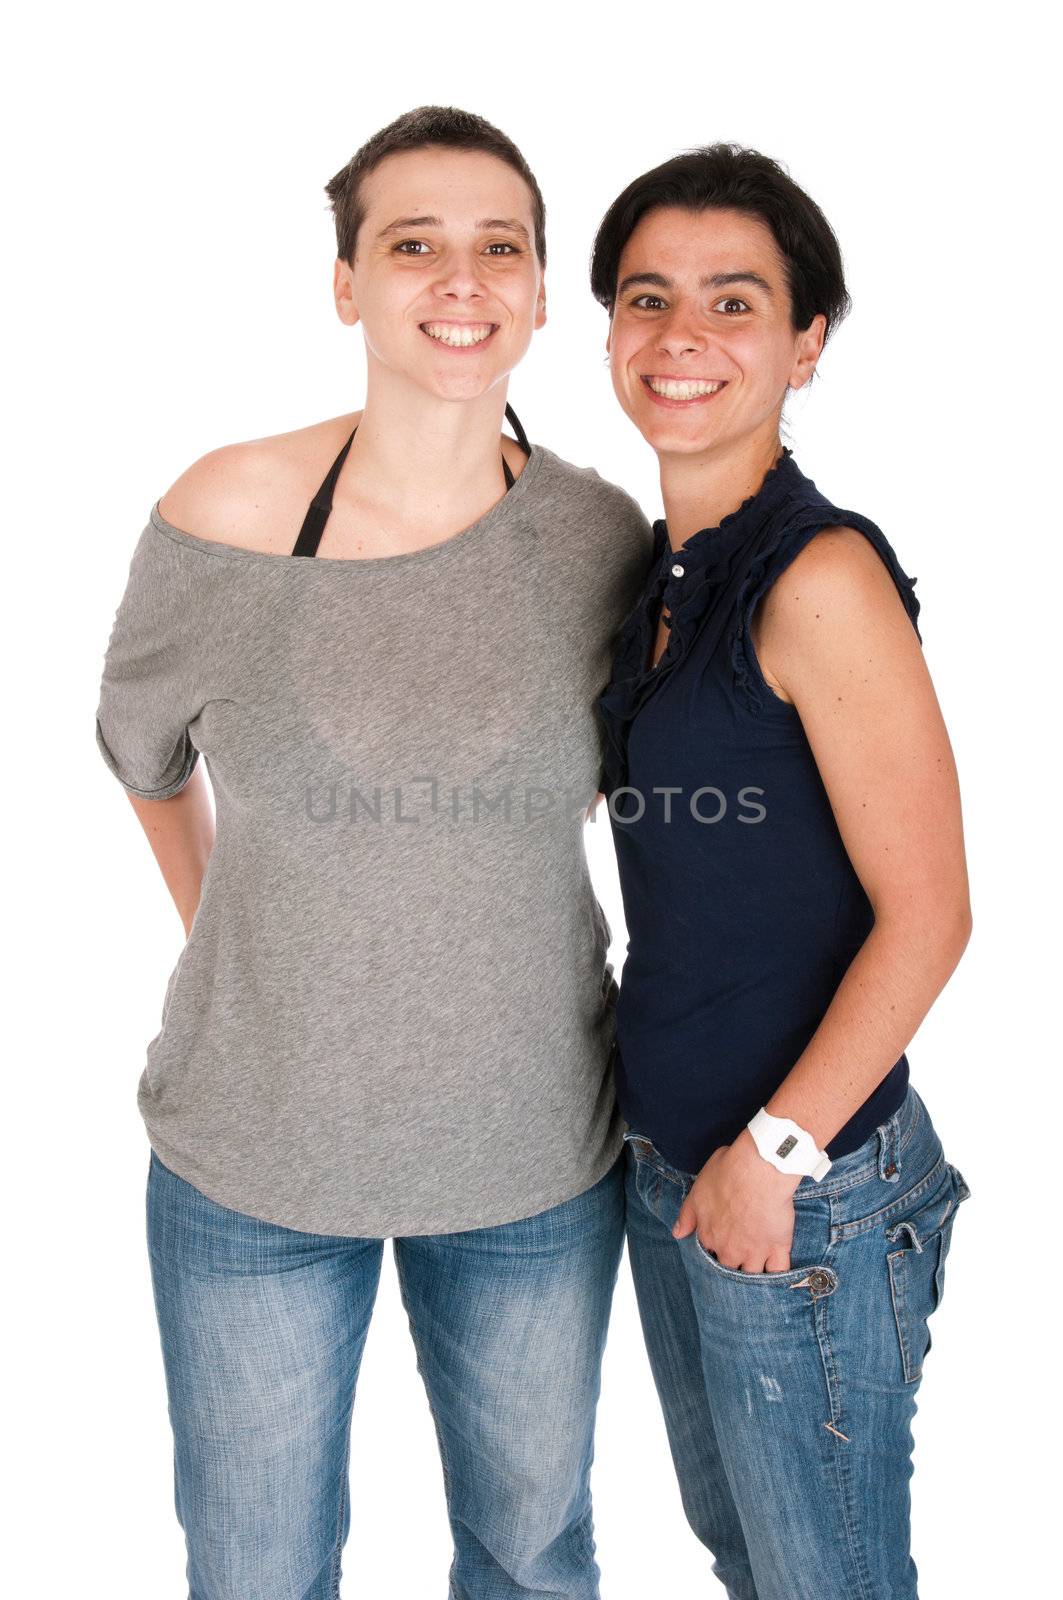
xmin=0 ymin=0 xmax=1063 ymax=1600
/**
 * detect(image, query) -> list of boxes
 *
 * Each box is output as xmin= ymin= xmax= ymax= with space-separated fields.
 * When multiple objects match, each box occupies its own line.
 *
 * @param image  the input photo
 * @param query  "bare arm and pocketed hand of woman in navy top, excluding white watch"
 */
xmin=677 ymin=528 xmax=972 ymax=1272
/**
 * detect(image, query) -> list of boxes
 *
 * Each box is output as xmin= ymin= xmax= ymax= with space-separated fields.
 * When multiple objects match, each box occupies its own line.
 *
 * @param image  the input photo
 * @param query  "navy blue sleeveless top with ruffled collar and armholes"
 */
xmin=599 ymin=451 xmax=921 ymax=1173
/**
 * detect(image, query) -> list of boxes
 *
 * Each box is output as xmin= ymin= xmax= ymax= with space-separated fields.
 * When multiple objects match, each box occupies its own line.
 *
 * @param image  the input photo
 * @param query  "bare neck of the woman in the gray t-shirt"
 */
xmin=351 ymin=355 xmax=506 ymax=507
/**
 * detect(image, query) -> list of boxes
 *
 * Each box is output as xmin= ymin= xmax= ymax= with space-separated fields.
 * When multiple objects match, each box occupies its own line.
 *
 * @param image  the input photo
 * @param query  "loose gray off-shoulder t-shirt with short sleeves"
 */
xmin=96 ymin=445 xmax=652 ymax=1237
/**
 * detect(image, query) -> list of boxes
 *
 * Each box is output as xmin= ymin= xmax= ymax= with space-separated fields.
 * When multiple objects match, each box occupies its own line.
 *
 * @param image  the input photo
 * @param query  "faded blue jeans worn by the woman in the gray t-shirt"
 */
xmin=147 ymin=1150 xmax=624 ymax=1600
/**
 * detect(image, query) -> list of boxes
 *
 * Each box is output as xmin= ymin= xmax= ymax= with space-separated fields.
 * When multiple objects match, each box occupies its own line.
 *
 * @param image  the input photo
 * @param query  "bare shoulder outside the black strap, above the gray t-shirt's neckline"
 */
xmin=158 ymin=411 xmax=362 ymax=555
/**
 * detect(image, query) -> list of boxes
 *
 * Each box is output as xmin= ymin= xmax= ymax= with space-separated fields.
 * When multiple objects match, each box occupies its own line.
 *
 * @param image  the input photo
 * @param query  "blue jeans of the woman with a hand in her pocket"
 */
xmin=626 ymin=1086 xmax=970 ymax=1600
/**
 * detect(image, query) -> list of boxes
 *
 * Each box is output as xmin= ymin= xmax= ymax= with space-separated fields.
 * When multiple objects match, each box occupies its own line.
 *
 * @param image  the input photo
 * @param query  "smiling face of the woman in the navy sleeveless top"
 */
xmin=605 ymin=206 xmax=826 ymax=454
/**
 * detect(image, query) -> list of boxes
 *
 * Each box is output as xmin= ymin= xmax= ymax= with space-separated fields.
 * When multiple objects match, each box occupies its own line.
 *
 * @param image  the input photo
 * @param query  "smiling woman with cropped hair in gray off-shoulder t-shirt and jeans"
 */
xmin=96 ymin=107 xmax=650 ymax=1600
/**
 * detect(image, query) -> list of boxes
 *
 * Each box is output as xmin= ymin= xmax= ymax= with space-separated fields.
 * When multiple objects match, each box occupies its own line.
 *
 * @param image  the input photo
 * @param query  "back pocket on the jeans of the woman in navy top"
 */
xmin=885 ymin=1162 xmax=970 ymax=1384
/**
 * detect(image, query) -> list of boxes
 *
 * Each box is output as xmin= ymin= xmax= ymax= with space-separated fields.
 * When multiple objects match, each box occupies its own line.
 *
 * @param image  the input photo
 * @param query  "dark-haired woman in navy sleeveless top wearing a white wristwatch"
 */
xmin=591 ymin=144 xmax=970 ymax=1600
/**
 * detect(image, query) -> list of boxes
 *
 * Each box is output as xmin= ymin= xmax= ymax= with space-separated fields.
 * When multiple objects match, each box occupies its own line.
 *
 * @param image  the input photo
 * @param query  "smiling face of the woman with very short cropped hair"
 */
xmin=335 ymin=146 xmax=546 ymax=400
